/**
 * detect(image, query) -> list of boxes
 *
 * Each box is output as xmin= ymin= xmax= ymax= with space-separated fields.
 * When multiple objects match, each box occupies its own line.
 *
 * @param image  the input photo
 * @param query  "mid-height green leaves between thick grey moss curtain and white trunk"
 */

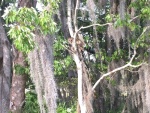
xmin=54 ymin=36 xmax=75 ymax=77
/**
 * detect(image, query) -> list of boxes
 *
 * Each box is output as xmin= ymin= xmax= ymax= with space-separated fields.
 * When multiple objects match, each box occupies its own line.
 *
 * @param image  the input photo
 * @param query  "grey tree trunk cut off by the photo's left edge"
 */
xmin=0 ymin=13 xmax=11 ymax=113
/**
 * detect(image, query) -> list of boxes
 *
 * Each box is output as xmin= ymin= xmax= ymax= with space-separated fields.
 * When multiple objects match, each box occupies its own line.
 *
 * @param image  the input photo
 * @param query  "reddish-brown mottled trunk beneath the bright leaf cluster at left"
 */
xmin=10 ymin=0 xmax=33 ymax=113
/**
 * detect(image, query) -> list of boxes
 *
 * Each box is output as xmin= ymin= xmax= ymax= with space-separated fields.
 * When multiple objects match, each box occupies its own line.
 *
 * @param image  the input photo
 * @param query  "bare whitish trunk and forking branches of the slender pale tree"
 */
xmin=67 ymin=5 xmax=150 ymax=113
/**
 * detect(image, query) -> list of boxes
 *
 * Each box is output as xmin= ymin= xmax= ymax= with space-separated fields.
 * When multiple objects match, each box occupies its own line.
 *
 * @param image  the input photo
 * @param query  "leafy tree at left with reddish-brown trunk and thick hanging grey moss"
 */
xmin=3 ymin=1 xmax=58 ymax=113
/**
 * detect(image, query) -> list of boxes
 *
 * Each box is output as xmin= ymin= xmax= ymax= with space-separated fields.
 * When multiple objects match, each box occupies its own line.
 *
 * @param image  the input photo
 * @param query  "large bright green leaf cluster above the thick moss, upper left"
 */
xmin=3 ymin=2 xmax=58 ymax=53
